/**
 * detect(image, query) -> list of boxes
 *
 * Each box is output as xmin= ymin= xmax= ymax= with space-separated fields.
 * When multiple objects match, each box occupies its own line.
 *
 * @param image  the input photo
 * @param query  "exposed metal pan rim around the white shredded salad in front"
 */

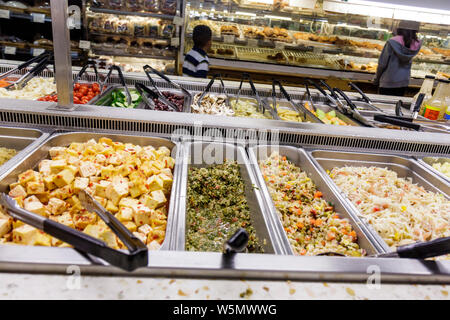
xmin=309 ymin=150 xmax=450 ymax=252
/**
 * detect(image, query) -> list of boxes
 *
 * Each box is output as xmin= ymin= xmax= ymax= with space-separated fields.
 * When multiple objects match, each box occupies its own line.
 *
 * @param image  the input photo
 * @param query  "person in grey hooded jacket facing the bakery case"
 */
xmin=374 ymin=21 xmax=422 ymax=96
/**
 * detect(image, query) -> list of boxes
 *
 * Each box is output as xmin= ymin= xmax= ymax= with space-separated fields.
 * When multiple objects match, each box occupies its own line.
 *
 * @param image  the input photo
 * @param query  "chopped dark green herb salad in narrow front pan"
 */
xmin=186 ymin=162 xmax=263 ymax=253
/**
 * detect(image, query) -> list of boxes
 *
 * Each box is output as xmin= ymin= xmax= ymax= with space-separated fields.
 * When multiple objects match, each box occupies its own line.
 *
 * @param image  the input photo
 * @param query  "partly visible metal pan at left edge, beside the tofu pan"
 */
xmin=0 ymin=127 xmax=48 ymax=173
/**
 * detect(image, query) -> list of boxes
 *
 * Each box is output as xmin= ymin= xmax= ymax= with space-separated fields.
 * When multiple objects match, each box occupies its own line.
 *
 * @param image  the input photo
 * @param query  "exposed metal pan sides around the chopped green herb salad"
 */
xmin=175 ymin=142 xmax=283 ymax=254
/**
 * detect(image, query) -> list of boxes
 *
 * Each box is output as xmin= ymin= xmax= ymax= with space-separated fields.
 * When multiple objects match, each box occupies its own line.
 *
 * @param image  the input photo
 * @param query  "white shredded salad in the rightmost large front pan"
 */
xmin=329 ymin=167 xmax=450 ymax=254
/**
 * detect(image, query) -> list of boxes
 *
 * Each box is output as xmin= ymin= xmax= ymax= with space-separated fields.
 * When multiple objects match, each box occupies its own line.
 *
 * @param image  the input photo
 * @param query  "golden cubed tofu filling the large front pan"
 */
xmin=0 ymin=138 xmax=175 ymax=250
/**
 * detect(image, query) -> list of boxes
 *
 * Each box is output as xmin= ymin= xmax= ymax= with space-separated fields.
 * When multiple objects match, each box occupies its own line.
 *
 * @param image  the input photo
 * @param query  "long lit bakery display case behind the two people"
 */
xmin=184 ymin=0 xmax=450 ymax=78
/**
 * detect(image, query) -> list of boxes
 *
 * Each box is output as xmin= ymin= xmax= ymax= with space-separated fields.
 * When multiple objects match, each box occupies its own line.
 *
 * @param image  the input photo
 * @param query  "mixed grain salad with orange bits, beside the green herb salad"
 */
xmin=259 ymin=152 xmax=366 ymax=257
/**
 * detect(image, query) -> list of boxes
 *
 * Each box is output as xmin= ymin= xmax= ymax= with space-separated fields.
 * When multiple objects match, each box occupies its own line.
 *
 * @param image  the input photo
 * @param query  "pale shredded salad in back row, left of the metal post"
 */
xmin=0 ymin=77 xmax=56 ymax=100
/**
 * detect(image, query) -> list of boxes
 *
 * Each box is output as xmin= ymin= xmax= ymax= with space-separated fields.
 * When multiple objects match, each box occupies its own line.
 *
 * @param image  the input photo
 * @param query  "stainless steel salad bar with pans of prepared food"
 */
xmin=0 ymin=60 xmax=450 ymax=283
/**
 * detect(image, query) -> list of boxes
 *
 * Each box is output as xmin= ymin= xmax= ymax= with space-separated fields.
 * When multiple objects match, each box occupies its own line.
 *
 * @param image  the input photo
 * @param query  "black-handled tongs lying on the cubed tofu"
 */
xmin=0 ymin=190 xmax=148 ymax=271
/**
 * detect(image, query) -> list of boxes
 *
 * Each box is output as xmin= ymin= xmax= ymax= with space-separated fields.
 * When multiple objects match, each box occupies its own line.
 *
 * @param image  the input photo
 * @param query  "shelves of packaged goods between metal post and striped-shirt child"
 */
xmin=86 ymin=0 xmax=182 ymax=74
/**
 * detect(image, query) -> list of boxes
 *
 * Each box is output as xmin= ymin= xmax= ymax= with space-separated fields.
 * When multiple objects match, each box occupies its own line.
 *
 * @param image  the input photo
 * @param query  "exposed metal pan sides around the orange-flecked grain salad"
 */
xmin=249 ymin=145 xmax=382 ymax=255
